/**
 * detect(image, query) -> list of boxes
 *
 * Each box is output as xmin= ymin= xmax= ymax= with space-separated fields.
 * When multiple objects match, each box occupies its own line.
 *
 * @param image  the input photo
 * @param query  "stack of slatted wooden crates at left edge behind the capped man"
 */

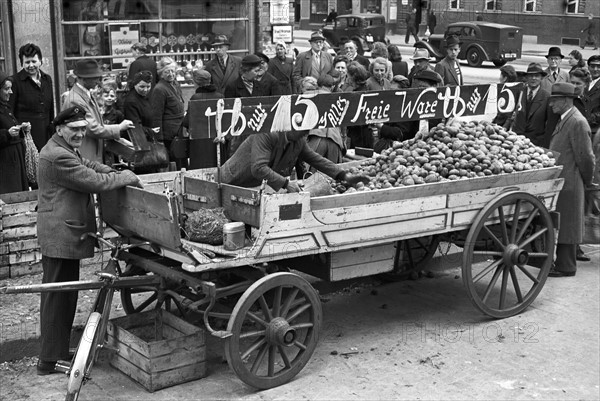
xmin=0 ymin=191 xmax=42 ymax=279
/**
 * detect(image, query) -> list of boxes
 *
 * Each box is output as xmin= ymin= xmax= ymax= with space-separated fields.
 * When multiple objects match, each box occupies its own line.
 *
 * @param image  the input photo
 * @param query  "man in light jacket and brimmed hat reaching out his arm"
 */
xmin=62 ymin=60 xmax=135 ymax=163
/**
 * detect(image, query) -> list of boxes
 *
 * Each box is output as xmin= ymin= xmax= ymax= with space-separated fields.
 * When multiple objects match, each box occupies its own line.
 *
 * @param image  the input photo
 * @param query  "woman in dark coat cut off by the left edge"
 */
xmin=0 ymin=71 xmax=31 ymax=194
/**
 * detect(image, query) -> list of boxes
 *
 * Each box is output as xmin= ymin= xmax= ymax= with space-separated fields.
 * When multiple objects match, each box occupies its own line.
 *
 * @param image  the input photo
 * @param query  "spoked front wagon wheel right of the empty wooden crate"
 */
xmin=225 ymin=273 xmax=322 ymax=389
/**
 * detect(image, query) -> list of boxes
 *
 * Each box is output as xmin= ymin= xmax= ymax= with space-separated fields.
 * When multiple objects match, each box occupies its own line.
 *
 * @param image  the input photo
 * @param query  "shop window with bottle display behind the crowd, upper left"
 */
xmin=62 ymin=0 xmax=251 ymax=70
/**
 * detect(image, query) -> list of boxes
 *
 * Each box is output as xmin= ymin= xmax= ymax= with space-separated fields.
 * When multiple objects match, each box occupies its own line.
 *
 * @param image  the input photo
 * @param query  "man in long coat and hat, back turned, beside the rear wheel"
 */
xmin=549 ymin=82 xmax=595 ymax=277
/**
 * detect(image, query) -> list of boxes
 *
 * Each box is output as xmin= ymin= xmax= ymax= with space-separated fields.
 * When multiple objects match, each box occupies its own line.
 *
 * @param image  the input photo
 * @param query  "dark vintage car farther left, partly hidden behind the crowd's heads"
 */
xmin=322 ymin=14 xmax=389 ymax=54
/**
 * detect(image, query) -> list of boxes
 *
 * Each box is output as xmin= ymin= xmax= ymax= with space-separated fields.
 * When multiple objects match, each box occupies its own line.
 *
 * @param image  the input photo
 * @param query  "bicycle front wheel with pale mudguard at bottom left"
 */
xmin=65 ymin=312 xmax=102 ymax=401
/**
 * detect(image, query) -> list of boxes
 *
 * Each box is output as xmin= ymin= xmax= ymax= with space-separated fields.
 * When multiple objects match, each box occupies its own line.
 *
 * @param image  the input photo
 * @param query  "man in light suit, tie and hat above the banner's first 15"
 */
xmin=292 ymin=32 xmax=333 ymax=93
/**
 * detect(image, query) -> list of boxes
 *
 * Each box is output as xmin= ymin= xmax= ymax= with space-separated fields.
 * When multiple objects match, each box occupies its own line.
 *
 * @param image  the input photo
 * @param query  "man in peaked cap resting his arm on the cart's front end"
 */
xmin=37 ymin=106 xmax=142 ymax=375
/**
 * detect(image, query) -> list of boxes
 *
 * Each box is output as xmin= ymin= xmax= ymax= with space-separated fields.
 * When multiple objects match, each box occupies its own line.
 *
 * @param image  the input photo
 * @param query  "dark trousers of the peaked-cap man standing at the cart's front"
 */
xmin=40 ymin=255 xmax=79 ymax=361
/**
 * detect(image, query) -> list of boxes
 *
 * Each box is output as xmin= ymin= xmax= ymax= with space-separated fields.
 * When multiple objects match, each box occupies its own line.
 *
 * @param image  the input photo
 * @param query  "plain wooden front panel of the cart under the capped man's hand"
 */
xmin=100 ymin=187 xmax=181 ymax=249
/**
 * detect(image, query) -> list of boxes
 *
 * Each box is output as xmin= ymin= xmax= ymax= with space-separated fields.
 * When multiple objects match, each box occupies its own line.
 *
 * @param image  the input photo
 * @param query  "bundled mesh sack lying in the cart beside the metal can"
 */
xmin=183 ymin=207 xmax=229 ymax=245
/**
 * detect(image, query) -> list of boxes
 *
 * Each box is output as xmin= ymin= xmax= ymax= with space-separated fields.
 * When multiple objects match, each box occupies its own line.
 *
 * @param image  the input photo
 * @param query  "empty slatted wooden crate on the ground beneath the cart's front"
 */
xmin=107 ymin=309 xmax=206 ymax=392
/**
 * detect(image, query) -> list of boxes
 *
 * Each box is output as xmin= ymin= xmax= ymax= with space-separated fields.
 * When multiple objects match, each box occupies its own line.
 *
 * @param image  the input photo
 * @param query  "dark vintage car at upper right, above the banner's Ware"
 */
xmin=415 ymin=21 xmax=523 ymax=67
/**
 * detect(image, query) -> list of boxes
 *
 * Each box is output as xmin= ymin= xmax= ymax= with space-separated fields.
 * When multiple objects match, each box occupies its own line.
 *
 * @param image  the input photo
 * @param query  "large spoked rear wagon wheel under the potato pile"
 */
xmin=462 ymin=192 xmax=554 ymax=318
